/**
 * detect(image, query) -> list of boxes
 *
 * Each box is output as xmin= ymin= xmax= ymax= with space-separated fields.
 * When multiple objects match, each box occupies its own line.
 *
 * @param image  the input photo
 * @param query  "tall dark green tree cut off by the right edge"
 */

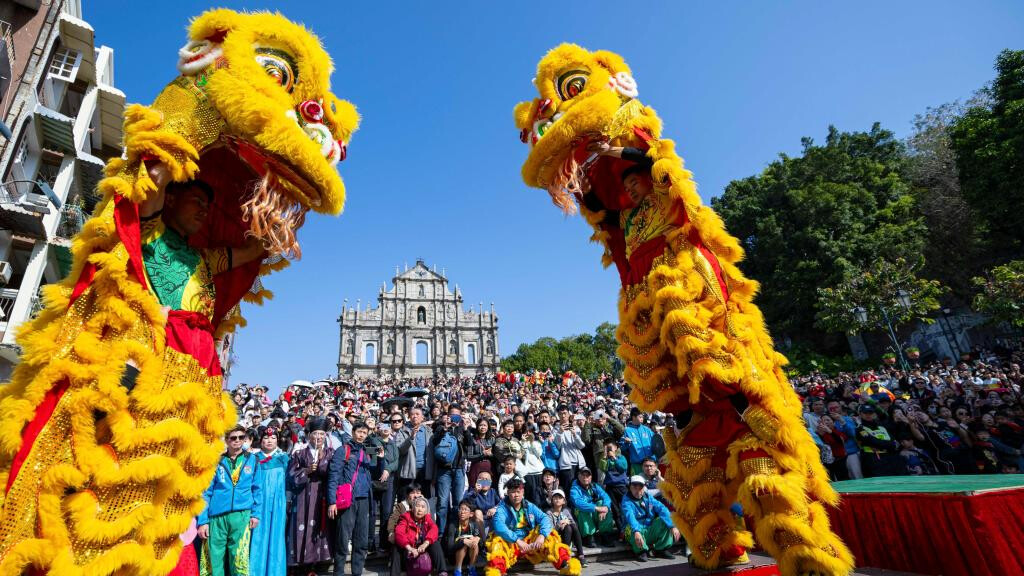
xmin=949 ymin=50 xmax=1024 ymax=263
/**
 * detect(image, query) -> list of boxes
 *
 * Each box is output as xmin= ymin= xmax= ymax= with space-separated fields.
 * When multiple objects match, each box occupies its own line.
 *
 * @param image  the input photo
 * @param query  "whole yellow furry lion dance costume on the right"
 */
xmin=515 ymin=44 xmax=853 ymax=576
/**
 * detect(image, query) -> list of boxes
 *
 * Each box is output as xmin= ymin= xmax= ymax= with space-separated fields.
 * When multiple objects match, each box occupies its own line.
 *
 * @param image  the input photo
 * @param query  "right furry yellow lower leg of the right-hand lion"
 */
xmin=737 ymin=450 xmax=853 ymax=576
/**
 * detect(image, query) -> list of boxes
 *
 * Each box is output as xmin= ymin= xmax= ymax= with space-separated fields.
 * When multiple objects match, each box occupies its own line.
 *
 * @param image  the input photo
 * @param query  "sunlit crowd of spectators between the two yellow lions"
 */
xmin=210 ymin=372 xmax=681 ymax=576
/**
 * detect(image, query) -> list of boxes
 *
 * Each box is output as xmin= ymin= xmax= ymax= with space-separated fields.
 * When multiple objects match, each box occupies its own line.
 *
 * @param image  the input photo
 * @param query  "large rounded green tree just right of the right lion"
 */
xmin=712 ymin=124 xmax=927 ymax=341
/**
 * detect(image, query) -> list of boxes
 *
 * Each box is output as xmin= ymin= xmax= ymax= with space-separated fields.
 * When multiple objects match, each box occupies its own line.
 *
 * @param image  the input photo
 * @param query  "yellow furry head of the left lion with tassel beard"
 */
xmin=171 ymin=9 xmax=359 ymax=257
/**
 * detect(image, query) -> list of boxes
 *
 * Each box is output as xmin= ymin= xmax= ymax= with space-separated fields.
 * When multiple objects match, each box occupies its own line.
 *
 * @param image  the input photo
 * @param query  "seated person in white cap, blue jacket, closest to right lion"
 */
xmin=623 ymin=475 xmax=681 ymax=562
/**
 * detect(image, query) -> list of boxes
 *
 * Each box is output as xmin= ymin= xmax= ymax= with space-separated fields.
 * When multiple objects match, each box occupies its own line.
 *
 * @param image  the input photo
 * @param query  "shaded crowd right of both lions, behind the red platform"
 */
xmin=793 ymin=347 xmax=1024 ymax=480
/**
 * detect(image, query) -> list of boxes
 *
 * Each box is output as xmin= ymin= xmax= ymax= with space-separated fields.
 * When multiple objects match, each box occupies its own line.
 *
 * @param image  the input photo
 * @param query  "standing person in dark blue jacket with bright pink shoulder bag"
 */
xmin=327 ymin=420 xmax=384 ymax=576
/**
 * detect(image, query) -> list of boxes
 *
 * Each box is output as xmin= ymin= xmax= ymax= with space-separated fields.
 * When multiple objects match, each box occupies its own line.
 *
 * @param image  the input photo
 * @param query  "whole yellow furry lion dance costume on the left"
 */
xmin=0 ymin=10 xmax=358 ymax=576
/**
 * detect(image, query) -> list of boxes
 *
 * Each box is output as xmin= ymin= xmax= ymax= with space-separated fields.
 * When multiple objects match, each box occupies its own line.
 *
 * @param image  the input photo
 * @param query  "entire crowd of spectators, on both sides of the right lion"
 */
xmin=200 ymin=342 xmax=1024 ymax=576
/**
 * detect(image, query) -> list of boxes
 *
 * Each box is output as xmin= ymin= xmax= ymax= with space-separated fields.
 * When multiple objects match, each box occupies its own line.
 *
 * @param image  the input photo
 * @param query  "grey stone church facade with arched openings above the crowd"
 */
xmin=338 ymin=260 xmax=501 ymax=379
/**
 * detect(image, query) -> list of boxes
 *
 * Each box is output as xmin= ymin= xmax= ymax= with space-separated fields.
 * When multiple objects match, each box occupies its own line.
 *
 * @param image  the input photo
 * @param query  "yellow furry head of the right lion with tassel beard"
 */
xmin=515 ymin=44 xmax=641 ymax=214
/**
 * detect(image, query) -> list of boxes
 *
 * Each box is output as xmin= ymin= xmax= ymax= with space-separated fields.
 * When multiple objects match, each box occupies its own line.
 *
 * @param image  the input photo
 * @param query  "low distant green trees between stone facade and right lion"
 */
xmin=502 ymin=322 xmax=617 ymax=377
